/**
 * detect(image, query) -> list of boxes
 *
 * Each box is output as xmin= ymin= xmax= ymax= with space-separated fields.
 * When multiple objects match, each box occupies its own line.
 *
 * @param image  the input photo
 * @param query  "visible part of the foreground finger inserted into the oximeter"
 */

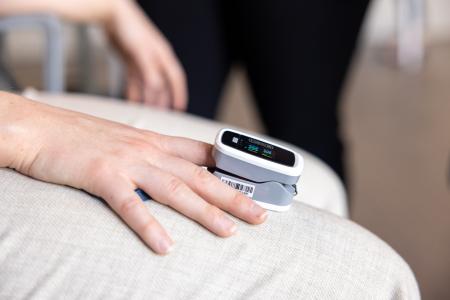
xmin=158 ymin=135 xmax=215 ymax=167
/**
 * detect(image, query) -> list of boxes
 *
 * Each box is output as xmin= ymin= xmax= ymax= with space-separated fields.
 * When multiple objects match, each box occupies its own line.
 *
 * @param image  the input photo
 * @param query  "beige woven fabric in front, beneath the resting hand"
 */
xmin=0 ymin=169 xmax=419 ymax=300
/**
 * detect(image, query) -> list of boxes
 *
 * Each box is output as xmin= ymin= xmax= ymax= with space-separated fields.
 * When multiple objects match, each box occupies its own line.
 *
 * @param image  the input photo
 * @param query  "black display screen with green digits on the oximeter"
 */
xmin=222 ymin=131 xmax=295 ymax=167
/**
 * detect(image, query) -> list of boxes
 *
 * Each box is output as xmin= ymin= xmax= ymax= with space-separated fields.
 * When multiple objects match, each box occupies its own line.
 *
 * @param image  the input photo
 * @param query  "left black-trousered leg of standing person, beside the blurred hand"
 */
xmin=139 ymin=0 xmax=231 ymax=119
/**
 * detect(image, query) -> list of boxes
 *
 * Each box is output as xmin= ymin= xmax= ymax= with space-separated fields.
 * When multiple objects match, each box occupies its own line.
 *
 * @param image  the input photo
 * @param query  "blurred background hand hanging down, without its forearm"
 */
xmin=106 ymin=0 xmax=187 ymax=110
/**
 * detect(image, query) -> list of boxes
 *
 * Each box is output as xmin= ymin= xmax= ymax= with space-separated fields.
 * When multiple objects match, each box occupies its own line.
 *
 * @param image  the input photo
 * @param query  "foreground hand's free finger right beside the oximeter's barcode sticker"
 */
xmin=156 ymin=156 xmax=267 ymax=224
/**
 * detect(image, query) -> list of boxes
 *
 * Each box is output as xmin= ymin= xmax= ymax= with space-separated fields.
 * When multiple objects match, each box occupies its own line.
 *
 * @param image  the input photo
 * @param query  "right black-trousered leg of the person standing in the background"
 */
xmin=227 ymin=0 xmax=368 ymax=177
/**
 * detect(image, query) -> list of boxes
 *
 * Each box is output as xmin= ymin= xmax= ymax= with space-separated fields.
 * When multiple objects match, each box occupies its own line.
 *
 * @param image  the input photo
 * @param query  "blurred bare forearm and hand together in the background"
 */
xmin=0 ymin=0 xmax=187 ymax=110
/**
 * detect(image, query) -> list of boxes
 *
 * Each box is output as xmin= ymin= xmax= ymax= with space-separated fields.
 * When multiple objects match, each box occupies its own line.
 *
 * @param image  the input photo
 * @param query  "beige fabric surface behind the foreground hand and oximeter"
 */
xmin=24 ymin=90 xmax=348 ymax=217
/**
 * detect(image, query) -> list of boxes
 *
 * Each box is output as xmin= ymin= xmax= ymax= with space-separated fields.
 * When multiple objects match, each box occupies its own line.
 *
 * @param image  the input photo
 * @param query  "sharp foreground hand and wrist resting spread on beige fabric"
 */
xmin=0 ymin=92 xmax=267 ymax=254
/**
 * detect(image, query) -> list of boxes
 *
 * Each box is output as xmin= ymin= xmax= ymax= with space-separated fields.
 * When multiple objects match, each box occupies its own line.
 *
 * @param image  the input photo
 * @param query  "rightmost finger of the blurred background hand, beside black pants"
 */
xmin=160 ymin=47 xmax=188 ymax=110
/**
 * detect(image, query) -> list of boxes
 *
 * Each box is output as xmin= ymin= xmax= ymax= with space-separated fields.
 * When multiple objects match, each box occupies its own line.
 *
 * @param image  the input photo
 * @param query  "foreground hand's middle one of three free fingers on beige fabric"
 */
xmin=135 ymin=166 xmax=237 ymax=237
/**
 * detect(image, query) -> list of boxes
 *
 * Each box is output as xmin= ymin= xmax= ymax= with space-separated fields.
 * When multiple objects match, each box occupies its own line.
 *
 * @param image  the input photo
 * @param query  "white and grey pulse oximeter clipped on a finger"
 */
xmin=210 ymin=129 xmax=304 ymax=211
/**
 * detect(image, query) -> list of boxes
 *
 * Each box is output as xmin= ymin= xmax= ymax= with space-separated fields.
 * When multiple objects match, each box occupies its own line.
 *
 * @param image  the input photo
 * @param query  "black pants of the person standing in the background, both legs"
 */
xmin=140 ymin=0 xmax=369 ymax=176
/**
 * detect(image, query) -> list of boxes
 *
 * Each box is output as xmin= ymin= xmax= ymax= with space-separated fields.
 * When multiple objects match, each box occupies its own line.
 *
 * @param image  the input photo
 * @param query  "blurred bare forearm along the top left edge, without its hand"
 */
xmin=0 ymin=0 xmax=128 ymax=23
